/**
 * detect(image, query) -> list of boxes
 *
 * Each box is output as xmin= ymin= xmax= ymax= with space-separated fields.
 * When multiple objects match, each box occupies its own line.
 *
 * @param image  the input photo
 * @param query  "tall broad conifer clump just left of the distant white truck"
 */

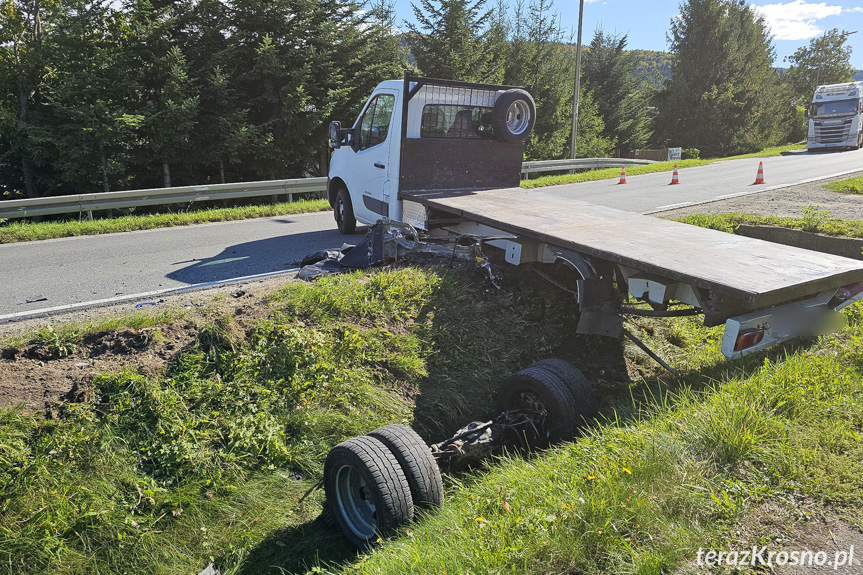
xmin=657 ymin=0 xmax=788 ymax=156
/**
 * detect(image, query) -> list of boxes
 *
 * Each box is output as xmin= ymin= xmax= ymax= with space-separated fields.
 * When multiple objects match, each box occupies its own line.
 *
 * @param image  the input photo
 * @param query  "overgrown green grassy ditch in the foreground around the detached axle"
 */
xmin=0 ymin=262 xmax=863 ymax=574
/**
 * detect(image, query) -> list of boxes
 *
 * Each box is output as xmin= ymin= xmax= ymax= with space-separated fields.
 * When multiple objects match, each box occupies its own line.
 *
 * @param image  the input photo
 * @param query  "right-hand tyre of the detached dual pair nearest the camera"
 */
xmin=369 ymin=424 xmax=443 ymax=509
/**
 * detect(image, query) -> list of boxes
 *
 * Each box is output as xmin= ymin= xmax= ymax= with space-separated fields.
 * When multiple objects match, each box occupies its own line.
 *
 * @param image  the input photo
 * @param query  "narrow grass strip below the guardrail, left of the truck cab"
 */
xmin=0 ymin=200 xmax=330 ymax=244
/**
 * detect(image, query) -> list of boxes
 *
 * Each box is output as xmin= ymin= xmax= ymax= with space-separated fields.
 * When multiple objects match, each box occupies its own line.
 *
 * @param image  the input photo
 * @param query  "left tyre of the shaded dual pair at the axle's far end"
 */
xmin=497 ymin=367 xmax=580 ymax=443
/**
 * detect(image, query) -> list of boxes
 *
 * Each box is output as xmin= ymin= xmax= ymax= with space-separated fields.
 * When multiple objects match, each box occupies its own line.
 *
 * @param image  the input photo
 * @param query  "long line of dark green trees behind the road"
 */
xmin=0 ymin=0 xmax=853 ymax=199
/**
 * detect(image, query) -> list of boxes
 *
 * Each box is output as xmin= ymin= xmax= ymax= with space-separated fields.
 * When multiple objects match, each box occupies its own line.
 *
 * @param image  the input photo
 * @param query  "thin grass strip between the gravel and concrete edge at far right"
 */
xmin=675 ymin=206 xmax=863 ymax=238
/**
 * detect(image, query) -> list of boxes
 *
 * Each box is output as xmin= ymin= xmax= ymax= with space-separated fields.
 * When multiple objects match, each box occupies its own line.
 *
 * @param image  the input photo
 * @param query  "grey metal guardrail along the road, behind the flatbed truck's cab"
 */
xmin=0 ymin=158 xmax=653 ymax=219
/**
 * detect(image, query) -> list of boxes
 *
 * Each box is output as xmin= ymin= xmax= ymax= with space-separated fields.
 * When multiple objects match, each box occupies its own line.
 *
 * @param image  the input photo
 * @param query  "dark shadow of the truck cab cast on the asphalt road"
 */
xmin=166 ymin=227 xmax=365 ymax=285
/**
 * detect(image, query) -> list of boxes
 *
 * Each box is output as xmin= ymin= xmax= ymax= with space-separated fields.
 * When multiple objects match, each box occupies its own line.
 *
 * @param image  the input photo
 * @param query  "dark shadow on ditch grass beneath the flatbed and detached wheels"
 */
xmin=226 ymin=262 xmax=814 ymax=575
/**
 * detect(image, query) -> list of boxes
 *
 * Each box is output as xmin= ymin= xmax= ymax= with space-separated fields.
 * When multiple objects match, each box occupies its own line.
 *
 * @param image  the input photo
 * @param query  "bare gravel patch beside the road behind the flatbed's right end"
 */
xmin=654 ymin=171 xmax=863 ymax=220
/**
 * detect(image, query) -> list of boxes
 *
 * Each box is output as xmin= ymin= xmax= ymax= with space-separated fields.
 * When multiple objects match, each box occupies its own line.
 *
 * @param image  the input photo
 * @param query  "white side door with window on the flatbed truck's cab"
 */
xmin=351 ymin=92 xmax=397 ymax=222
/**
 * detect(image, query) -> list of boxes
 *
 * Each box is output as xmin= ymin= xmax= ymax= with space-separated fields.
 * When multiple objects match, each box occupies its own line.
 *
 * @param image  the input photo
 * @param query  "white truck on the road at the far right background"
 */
xmin=806 ymin=82 xmax=863 ymax=152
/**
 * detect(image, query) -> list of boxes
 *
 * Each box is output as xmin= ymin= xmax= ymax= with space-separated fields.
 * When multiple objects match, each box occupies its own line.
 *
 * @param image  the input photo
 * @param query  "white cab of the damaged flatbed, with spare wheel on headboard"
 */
xmin=327 ymin=74 xmax=536 ymax=234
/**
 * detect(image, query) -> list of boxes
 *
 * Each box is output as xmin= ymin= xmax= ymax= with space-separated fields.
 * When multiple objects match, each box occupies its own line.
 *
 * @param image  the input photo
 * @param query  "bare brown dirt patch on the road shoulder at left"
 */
xmin=0 ymin=278 xmax=292 ymax=416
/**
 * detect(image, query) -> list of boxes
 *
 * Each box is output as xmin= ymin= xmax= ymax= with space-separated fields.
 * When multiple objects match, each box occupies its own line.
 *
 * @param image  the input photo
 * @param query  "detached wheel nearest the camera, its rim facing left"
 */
xmin=324 ymin=437 xmax=414 ymax=549
